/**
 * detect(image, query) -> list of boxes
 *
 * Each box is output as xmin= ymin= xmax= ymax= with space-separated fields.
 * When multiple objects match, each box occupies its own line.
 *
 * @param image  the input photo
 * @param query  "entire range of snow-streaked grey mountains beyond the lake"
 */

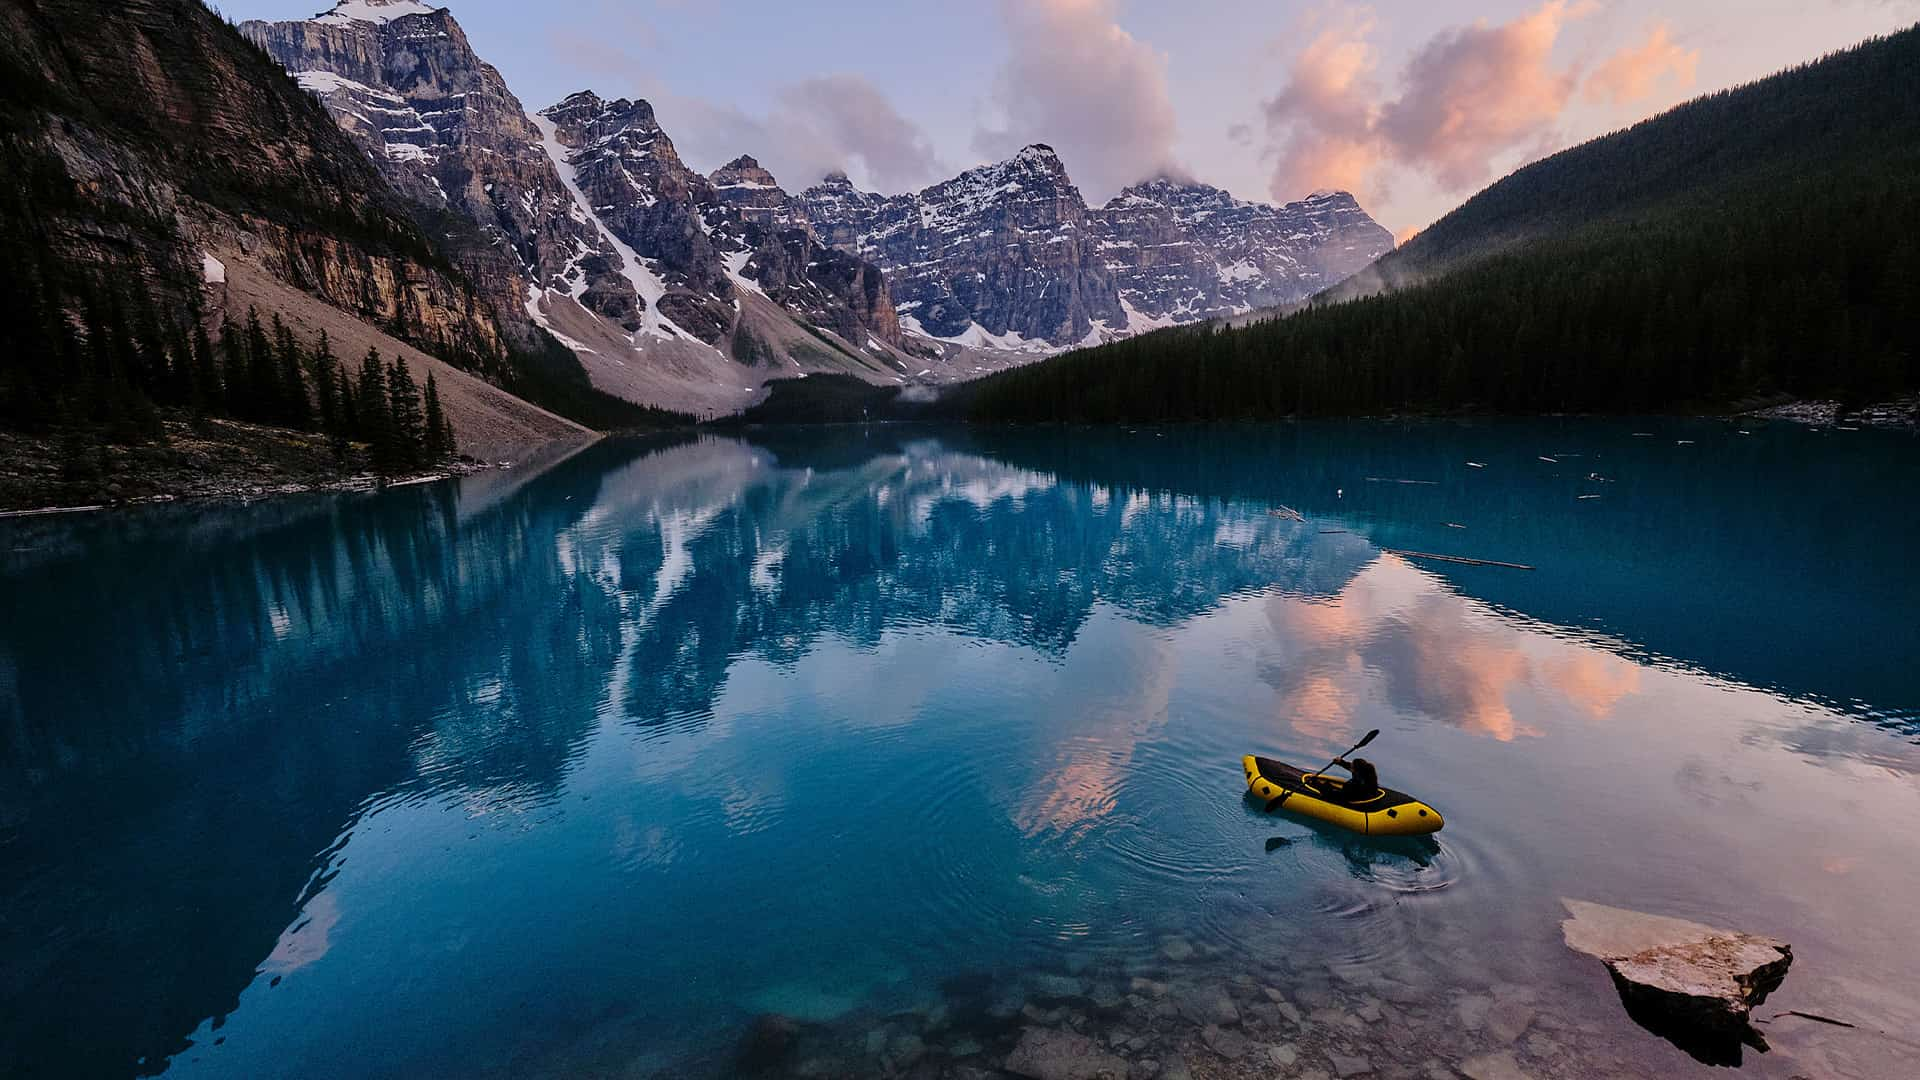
xmin=242 ymin=0 xmax=1392 ymax=409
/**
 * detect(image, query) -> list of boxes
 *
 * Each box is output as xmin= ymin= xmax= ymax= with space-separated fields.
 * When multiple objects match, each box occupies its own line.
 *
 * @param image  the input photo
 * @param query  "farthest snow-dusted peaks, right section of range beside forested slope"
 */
xmin=801 ymin=144 xmax=1394 ymax=350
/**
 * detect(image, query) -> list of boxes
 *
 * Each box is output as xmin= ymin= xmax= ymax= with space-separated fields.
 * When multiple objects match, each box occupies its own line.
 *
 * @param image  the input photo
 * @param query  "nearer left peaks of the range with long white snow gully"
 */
xmin=242 ymin=0 xmax=904 ymax=396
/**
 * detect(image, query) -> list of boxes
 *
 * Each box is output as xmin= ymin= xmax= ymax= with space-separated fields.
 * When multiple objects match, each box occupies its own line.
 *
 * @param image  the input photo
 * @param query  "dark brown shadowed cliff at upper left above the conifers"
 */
xmin=0 ymin=0 xmax=511 ymax=363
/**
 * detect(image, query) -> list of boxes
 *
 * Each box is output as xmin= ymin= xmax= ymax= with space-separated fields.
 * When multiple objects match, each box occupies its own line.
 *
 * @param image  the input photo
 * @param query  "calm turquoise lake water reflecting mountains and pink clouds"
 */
xmin=0 ymin=421 xmax=1920 ymax=1078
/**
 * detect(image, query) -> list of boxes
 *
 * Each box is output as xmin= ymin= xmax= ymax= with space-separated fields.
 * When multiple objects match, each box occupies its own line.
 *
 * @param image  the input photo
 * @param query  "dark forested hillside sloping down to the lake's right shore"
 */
xmin=967 ymin=29 xmax=1920 ymax=421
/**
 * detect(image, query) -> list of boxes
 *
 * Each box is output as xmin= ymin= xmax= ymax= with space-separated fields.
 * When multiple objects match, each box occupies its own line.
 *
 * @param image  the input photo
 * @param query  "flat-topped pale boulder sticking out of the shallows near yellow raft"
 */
xmin=1561 ymin=899 xmax=1793 ymax=1057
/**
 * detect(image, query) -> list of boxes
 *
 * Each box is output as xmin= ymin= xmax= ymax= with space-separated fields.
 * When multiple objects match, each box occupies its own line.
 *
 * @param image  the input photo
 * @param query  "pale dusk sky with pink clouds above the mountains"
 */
xmin=217 ymin=0 xmax=1920 ymax=238
